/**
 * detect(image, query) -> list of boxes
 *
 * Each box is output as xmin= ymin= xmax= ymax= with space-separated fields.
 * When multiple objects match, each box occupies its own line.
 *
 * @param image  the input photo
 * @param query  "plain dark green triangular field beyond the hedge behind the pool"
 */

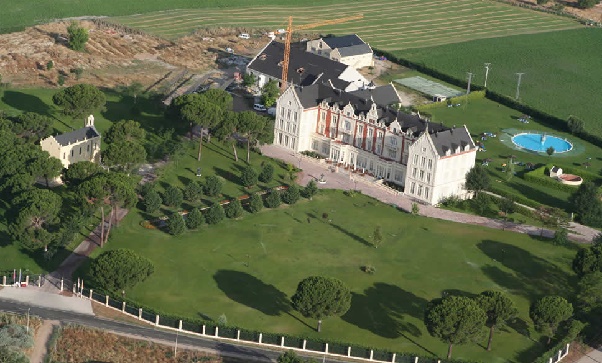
xmin=396 ymin=28 xmax=602 ymax=136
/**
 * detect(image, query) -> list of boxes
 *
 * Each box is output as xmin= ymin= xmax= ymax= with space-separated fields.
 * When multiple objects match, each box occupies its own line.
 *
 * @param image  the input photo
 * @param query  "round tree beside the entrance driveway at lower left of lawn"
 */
xmin=90 ymin=249 xmax=155 ymax=292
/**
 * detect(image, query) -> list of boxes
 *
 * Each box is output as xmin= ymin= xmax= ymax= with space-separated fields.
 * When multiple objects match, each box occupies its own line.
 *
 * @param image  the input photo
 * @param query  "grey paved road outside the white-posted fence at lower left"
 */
xmin=0 ymin=298 xmax=352 ymax=363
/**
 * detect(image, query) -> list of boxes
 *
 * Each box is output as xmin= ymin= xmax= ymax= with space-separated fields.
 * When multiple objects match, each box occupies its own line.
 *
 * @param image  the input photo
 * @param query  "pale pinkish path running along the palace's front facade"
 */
xmin=261 ymin=145 xmax=600 ymax=243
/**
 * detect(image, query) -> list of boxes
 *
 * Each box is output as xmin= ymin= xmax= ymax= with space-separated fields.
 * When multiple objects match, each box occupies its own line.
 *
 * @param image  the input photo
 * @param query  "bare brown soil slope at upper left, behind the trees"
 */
xmin=0 ymin=21 xmax=265 ymax=87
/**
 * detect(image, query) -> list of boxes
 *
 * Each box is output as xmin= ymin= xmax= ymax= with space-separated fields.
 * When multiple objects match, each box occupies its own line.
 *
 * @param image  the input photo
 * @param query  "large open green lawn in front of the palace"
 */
xmin=79 ymin=191 xmax=576 ymax=362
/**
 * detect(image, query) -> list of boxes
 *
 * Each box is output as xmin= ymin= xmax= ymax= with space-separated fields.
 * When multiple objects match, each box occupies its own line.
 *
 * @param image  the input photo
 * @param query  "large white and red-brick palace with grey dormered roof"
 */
xmin=274 ymin=82 xmax=476 ymax=204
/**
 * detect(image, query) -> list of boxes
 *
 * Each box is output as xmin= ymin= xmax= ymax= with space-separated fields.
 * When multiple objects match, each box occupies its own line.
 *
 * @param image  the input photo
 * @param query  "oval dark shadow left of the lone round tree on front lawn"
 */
xmin=213 ymin=270 xmax=290 ymax=316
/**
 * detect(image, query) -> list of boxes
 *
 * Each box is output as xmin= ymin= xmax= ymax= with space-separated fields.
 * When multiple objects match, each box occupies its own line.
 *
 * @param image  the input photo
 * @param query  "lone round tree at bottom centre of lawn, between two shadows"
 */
xmin=291 ymin=276 xmax=351 ymax=331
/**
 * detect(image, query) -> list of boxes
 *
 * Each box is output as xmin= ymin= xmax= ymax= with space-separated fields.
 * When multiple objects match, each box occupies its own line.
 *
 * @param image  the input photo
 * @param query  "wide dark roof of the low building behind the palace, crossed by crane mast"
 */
xmin=247 ymin=41 xmax=350 ymax=89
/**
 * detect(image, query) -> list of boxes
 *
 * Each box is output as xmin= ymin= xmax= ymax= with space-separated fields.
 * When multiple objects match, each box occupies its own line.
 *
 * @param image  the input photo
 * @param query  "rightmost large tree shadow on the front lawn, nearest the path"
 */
xmin=477 ymin=240 xmax=577 ymax=299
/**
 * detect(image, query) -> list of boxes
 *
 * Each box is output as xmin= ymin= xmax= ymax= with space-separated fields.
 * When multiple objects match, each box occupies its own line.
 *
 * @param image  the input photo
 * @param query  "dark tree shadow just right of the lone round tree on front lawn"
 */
xmin=343 ymin=282 xmax=434 ymax=355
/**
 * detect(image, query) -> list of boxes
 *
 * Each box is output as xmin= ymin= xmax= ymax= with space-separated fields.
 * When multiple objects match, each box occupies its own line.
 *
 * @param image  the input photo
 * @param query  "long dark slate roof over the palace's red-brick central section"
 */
xmin=295 ymin=83 xmax=448 ymax=136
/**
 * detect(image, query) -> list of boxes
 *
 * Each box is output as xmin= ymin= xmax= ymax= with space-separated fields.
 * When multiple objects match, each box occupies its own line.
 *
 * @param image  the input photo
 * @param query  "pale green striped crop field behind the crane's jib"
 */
xmin=110 ymin=0 xmax=579 ymax=46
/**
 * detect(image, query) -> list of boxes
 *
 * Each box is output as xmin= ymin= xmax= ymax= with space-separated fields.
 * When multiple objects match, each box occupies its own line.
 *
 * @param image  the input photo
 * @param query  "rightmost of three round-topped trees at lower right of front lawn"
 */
xmin=529 ymin=296 xmax=573 ymax=344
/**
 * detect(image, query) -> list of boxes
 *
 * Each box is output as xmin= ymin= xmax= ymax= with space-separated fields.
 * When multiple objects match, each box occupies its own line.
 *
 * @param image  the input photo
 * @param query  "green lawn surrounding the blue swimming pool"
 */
xmin=418 ymin=99 xmax=602 ymax=209
